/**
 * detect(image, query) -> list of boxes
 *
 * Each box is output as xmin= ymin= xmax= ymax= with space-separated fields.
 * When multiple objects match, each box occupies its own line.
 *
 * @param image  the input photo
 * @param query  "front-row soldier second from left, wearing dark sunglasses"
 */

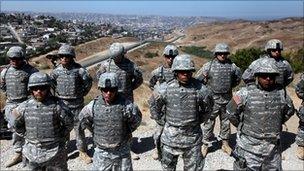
xmin=78 ymin=73 xmax=142 ymax=170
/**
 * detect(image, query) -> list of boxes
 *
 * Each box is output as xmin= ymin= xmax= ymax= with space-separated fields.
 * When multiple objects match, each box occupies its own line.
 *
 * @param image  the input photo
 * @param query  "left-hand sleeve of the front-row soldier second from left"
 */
xmin=76 ymin=100 xmax=95 ymax=133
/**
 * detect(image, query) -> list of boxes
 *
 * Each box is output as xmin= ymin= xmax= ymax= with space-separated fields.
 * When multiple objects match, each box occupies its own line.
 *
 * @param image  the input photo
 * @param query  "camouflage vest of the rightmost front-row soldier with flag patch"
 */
xmin=240 ymin=86 xmax=285 ymax=138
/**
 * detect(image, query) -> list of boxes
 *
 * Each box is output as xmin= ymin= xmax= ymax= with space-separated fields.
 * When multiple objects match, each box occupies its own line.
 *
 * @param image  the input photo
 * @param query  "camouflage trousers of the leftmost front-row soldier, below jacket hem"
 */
xmin=27 ymin=149 xmax=68 ymax=171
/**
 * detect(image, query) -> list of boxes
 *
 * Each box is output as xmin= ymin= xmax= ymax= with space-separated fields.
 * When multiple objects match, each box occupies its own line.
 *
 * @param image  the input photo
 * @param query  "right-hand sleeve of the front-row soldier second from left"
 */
xmin=125 ymin=103 xmax=142 ymax=132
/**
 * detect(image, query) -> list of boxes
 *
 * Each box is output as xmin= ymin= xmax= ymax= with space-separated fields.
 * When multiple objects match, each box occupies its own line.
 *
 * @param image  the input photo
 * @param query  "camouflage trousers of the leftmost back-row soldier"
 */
xmin=5 ymin=103 xmax=24 ymax=153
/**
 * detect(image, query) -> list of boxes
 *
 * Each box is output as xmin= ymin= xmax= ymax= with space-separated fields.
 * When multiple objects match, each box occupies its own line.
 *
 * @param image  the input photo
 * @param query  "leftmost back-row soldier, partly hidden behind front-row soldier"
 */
xmin=1 ymin=46 xmax=38 ymax=167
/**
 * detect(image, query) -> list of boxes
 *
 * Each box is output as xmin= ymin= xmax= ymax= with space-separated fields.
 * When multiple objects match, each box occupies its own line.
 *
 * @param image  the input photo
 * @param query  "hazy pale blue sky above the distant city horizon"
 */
xmin=1 ymin=0 xmax=304 ymax=19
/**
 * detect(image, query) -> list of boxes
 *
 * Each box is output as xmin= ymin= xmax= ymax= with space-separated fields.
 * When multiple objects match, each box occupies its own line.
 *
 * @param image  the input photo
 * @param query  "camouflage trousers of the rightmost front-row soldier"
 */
xmin=235 ymin=146 xmax=282 ymax=171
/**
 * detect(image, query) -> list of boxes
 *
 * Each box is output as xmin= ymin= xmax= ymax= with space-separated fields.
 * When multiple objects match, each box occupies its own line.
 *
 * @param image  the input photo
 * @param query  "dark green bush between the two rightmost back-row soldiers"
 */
xmin=230 ymin=48 xmax=263 ymax=71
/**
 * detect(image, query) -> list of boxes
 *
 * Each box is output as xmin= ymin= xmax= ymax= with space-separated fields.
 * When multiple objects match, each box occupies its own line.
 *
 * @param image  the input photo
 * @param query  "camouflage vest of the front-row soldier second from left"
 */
xmin=93 ymin=97 xmax=129 ymax=148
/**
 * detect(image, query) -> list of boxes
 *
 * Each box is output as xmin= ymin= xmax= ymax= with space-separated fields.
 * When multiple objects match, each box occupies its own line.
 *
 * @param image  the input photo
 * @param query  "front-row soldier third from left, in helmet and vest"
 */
xmin=149 ymin=54 xmax=213 ymax=170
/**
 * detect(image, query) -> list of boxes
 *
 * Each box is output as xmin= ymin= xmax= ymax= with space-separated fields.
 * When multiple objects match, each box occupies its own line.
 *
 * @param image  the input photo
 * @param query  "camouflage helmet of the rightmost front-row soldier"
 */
xmin=254 ymin=58 xmax=279 ymax=76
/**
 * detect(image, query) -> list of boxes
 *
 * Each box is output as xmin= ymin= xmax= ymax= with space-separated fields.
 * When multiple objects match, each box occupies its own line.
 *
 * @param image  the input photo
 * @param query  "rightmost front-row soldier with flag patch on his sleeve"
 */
xmin=227 ymin=58 xmax=295 ymax=170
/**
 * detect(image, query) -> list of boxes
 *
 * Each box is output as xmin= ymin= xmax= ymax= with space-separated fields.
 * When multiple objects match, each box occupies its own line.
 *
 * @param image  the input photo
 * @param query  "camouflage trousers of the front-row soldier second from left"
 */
xmin=92 ymin=147 xmax=133 ymax=171
